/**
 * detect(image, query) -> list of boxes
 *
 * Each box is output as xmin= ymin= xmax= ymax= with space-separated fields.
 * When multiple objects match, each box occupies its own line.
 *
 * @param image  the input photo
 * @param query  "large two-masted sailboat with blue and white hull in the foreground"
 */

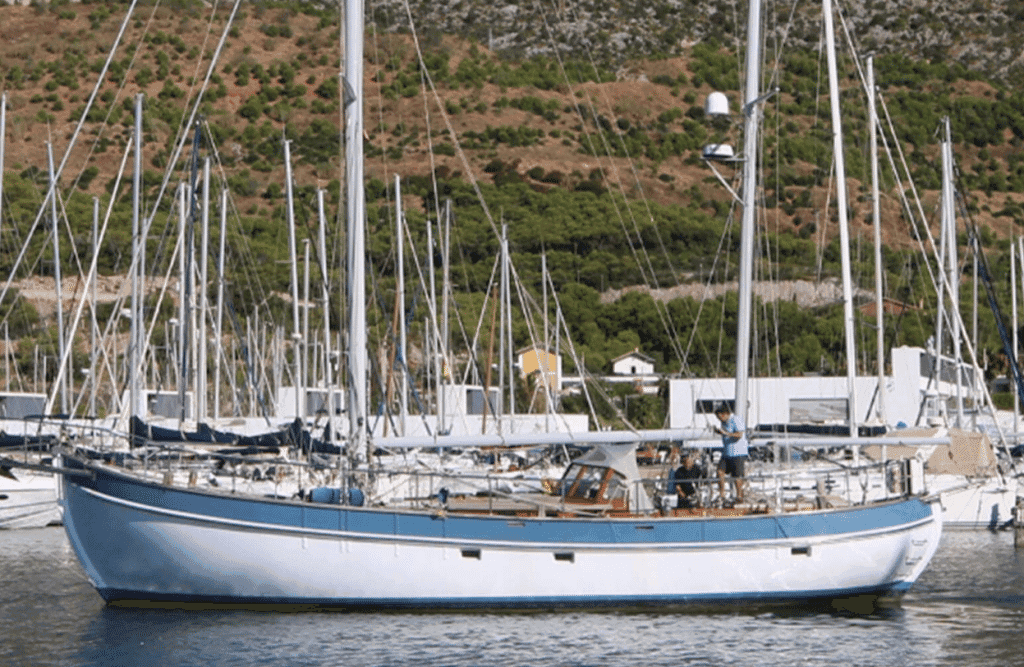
xmin=51 ymin=0 xmax=941 ymax=610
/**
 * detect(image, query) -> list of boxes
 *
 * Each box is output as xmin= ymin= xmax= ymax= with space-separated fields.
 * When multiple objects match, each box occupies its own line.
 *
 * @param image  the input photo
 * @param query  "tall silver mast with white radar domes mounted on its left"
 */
xmin=735 ymin=0 xmax=761 ymax=424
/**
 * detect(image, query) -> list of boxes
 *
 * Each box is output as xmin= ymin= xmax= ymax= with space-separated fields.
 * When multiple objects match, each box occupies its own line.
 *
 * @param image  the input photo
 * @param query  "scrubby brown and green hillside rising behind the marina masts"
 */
xmin=0 ymin=0 xmax=1024 ymax=411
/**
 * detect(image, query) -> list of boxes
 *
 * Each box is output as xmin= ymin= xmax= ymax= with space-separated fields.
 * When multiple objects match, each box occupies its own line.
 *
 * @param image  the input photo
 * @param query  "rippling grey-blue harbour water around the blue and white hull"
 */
xmin=0 ymin=529 xmax=1024 ymax=667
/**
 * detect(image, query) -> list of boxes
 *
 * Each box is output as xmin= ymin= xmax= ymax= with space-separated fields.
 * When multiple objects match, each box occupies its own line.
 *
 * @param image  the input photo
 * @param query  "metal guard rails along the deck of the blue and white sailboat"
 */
xmin=18 ymin=419 xmax=929 ymax=516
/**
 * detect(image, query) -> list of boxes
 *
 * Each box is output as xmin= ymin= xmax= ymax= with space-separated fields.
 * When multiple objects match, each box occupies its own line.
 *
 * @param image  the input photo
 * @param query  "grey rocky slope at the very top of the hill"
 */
xmin=374 ymin=0 xmax=1024 ymax=84
